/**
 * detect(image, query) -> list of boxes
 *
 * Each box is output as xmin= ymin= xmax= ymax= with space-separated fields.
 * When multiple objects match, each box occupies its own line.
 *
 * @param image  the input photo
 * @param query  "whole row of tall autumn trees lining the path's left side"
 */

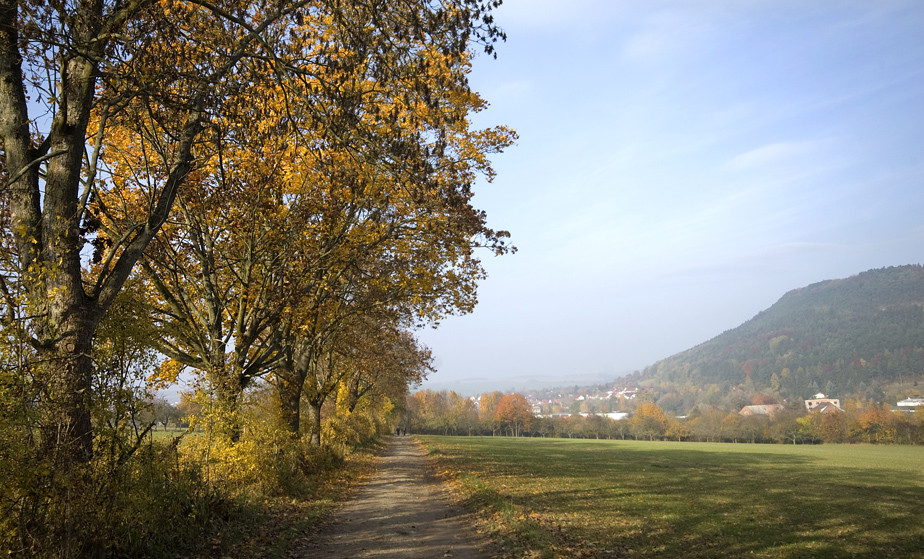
xmin=0 ymin=0 xmax=515 ymax=555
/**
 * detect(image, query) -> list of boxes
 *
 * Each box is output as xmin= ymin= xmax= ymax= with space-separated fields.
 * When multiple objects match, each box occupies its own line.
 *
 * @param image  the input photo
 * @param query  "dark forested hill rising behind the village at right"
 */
xmin=632 ymin=265 xmax=924 ymax=411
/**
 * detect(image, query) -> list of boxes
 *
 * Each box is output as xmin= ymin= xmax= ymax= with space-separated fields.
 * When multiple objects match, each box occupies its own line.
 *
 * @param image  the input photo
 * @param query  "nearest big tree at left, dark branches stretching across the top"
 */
xmin=0 ymin=0 xmax=502 ymax=462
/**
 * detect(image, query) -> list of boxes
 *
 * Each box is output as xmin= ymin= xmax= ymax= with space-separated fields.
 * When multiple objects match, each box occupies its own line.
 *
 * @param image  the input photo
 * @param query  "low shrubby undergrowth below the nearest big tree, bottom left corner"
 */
xmin=0 ymin=440 xmax=233 ymax=557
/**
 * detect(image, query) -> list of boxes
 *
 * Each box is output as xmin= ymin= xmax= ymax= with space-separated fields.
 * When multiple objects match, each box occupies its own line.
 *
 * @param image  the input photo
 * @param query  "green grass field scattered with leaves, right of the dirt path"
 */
xmin=420 ymin=437 xmax=924 ymax=559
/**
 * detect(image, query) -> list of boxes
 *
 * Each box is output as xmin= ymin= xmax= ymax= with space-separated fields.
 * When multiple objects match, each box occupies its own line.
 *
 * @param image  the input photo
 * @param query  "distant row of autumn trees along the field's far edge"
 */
xmin=406 ymin=390 xmax=924 ymax=444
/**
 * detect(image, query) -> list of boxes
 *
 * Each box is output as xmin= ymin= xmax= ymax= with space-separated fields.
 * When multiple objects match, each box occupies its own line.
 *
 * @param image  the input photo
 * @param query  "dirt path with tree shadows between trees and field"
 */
xmin=301 ymin=437 xmax=492 ymax=559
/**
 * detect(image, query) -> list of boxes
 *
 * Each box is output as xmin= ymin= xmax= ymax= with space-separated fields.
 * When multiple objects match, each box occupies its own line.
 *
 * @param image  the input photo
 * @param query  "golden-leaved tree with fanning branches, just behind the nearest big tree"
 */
xmin=102 ymin=82 xmax=315 ymax=439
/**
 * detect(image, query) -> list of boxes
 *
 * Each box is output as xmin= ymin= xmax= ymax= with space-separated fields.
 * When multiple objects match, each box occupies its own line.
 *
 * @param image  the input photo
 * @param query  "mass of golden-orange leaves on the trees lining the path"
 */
xmin=83 ymin=0 xmax=515 ymax=446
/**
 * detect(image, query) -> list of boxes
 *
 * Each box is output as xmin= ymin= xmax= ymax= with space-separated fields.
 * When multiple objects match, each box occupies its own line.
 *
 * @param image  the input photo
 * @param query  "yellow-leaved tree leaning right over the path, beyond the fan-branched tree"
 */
xmin=275 ymin=40 xmax=514 ymax=444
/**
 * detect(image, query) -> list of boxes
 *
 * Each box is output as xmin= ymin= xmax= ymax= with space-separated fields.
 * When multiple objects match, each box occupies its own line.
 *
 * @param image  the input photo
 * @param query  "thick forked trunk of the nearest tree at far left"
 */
xmin=0 ymin=0 xmax=189 ymax=468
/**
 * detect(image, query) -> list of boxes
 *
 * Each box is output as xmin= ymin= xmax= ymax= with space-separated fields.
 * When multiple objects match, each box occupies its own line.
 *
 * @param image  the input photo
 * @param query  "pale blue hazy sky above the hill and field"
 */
xmin=418 ymin=0 xmax=924 ymax=394
